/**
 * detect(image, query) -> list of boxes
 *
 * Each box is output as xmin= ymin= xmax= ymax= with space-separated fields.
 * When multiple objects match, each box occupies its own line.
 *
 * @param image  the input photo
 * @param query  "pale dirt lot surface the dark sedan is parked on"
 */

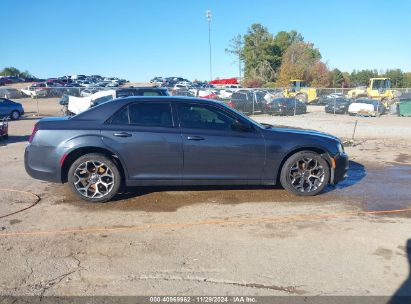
xmin=0 ymin=99 xmax=411 ymax=296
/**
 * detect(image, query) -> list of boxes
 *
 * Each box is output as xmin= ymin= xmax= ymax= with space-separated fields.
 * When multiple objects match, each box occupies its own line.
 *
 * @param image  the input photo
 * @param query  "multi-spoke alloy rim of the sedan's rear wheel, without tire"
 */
xmin=74 ymin=160 xmax=114 ymax=198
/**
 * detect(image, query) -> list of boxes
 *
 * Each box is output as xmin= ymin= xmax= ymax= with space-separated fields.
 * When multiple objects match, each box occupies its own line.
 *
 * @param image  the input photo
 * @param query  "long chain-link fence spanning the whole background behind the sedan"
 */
xmin=0 ymin=85 xmax=411 ymax=116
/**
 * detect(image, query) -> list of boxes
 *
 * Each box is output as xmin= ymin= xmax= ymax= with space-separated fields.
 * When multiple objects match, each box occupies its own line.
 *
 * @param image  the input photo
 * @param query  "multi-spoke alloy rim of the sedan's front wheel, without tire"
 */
xmin=288 ymin=157 xmax=325 ymax=193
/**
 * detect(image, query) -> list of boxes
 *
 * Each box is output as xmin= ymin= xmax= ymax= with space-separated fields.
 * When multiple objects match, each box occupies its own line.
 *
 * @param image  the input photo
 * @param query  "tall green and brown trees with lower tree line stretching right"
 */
xmin=225 ymin=23 xmax=411 ymax=88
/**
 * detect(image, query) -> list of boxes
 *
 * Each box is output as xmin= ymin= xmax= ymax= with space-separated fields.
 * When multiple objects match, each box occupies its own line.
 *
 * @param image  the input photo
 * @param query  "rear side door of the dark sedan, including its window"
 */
xmin=101 ymin=100 xmax=183 ymax=185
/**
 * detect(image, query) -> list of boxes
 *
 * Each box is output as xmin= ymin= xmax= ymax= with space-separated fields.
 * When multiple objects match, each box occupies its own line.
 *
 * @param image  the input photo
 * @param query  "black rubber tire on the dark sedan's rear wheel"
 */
xmin=68 ymin=153 xmax=122 ymax=203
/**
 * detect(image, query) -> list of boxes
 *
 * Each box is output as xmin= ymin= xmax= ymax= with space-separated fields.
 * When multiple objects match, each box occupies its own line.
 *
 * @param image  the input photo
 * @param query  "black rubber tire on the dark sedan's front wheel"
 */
xmin=280 ymin=151 xmax=330 ymax=196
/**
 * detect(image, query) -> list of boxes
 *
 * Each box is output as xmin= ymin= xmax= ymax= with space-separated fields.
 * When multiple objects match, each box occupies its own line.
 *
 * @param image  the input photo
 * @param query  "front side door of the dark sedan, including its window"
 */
xmin=174 ymin=102 xmax=266 ymax=185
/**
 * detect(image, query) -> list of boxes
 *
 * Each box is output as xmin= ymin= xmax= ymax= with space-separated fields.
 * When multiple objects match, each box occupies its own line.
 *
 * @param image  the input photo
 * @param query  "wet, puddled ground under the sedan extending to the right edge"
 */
xmin=54 ymin=161 xmax=411 ymax=214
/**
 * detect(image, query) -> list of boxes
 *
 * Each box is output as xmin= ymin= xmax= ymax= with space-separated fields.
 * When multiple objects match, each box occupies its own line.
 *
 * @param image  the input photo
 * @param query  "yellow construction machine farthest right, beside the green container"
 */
xmin=347 ymin=77 xmax=400 ymax=106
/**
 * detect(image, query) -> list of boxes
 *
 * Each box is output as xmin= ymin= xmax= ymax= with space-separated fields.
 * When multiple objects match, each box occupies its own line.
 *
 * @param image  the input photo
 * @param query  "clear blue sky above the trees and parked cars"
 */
xmin=0 ymin=0 xmax=411 ymax=81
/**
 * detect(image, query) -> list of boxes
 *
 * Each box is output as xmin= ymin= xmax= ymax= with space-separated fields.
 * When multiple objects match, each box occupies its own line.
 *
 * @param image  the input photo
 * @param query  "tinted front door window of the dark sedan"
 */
xmin=178 ymin=104 xmax=237 ymax=130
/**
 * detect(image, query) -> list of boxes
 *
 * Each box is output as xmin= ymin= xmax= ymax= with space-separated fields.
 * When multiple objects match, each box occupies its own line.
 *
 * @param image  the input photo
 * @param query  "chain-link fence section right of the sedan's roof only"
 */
xmin=171 ymin=87 xmax=411 ymax=116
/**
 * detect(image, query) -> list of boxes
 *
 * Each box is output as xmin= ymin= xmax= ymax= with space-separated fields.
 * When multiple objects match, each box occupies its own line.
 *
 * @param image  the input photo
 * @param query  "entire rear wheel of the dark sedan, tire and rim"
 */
xmin=68 ymin=153 xmax=121 ymax=203
